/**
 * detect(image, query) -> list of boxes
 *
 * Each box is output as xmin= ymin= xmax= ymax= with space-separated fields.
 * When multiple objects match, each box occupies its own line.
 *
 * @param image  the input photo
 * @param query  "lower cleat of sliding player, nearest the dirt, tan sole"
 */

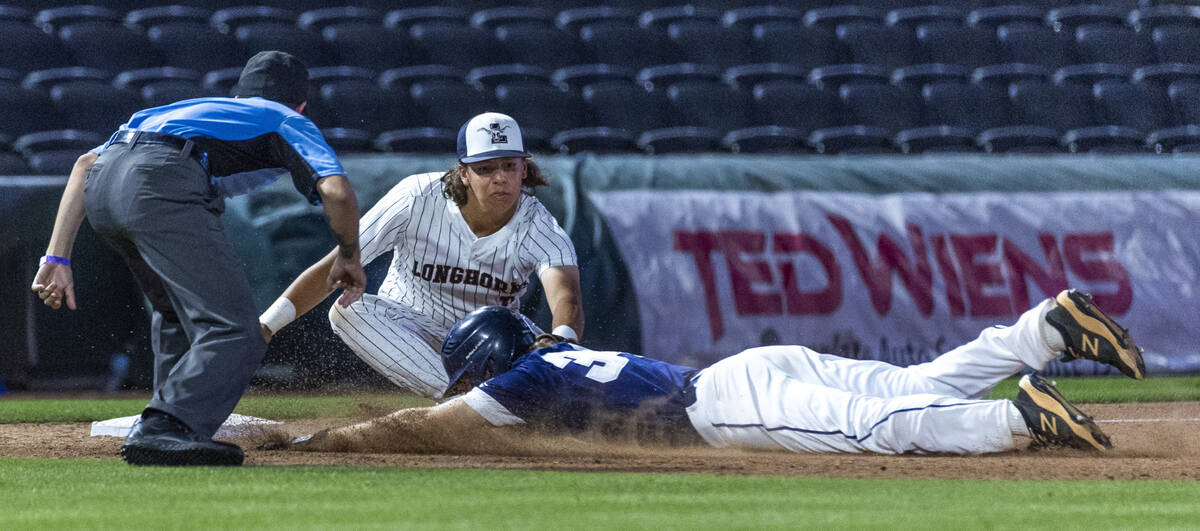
xmin=1013 ymin=375 xmax=1112 ymax=451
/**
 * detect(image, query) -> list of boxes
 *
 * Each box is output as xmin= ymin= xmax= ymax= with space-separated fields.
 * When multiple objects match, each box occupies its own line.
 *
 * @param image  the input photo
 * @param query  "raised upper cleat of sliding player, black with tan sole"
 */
xmin=1046 ymin=290 xmax=1146 ymax=380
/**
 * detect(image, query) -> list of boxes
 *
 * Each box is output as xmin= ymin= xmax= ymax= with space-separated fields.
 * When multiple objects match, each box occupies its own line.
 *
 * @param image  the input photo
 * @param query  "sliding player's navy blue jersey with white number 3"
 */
xmin=466 ymin=342 xmax=697 ymax=432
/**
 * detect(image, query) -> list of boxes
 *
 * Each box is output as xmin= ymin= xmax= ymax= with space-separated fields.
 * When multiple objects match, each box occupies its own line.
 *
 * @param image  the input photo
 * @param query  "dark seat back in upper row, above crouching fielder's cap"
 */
xmin=409 ymin=23 xmax=511 ymax=68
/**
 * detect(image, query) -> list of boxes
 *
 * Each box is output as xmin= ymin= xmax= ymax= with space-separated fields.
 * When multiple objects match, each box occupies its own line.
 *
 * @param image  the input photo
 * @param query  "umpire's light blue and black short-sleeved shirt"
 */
xmin=90 ymin=97 xmax=346 ymax=204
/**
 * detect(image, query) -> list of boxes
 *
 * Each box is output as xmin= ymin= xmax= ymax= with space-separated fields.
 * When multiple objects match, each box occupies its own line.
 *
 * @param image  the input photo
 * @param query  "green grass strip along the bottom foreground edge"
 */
xmin=0 ymin=459 xmax=1200 ymax=530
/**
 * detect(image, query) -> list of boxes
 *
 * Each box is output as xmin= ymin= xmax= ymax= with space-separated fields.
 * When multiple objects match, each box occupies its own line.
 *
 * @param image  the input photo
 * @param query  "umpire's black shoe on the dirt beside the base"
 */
xmin=121 ymin=410 xmax=245 ymax=466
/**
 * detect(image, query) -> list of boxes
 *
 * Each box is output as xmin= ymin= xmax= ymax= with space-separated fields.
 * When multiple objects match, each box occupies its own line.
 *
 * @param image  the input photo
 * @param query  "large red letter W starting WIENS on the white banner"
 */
xmin=827 ymin=214 xmax=934 ymax=316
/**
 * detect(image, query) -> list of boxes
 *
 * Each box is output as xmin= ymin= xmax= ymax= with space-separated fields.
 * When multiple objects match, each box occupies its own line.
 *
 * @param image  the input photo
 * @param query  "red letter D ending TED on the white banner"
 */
xmin=774 ymin=234 xmax=841 ymax=315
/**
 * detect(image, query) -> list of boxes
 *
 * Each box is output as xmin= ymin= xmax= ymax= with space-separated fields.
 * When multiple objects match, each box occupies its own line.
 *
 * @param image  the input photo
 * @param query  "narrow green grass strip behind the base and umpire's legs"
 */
xmin=0 ymin=394 xmax=431 ymax=424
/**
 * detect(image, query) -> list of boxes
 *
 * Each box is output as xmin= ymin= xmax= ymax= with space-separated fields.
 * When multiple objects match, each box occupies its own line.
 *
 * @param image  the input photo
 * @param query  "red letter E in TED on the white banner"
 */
xmin=718 ymin=231 xmax=784 ymax=315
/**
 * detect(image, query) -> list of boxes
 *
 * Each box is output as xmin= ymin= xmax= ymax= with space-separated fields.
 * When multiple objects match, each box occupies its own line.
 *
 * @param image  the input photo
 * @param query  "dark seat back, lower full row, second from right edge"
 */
xmin=1092 ymin=80 xmax=1182 ymax=132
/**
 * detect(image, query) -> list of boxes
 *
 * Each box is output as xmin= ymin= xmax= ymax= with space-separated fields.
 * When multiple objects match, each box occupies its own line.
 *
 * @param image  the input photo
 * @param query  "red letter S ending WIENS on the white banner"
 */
xmin=1062 ymin=232 xmax=1133 ymax=315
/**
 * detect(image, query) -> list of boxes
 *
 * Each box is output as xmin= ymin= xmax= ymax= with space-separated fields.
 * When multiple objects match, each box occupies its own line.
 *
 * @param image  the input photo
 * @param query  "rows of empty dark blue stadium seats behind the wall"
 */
xmin=0 ymin=0 xmax=1200 ymax=163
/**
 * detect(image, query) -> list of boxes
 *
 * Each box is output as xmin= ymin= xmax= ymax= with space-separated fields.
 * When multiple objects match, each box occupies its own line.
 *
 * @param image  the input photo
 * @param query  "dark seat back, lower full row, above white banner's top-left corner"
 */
xmin=580 ymin=80 xmax=667 ymax=135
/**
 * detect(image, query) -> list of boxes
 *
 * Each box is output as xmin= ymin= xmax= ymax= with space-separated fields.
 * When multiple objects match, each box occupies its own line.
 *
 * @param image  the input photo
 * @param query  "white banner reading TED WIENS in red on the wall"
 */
xmin=589 ymin=190 xmax=1200 ymax=374
